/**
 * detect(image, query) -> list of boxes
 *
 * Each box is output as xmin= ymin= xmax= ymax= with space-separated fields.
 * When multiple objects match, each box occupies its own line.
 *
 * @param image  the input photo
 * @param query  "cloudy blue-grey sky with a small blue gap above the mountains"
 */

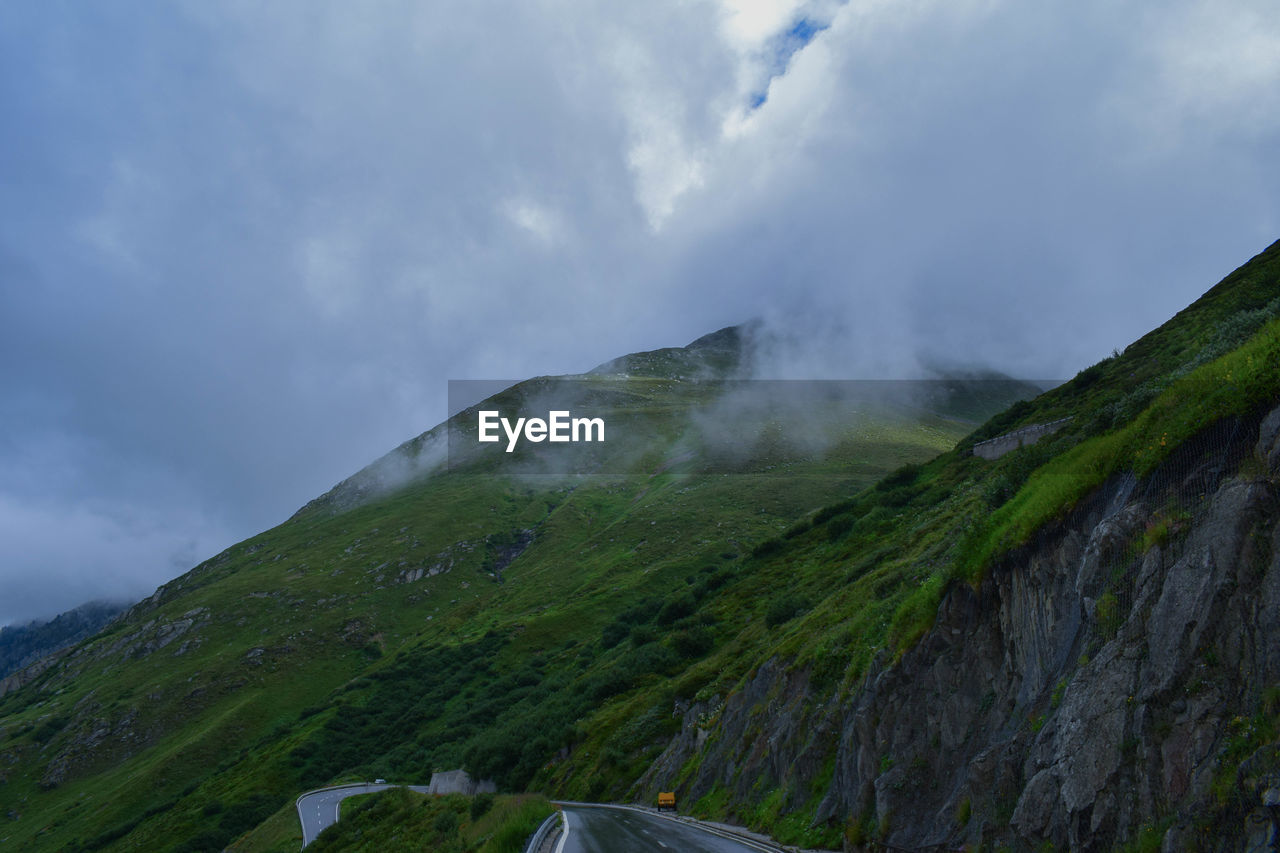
xmin=0 ymin=0 xmax=1280 ymax=624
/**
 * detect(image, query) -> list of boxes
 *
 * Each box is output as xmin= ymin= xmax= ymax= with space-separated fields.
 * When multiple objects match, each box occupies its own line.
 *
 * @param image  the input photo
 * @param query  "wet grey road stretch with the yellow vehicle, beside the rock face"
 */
xmin=556 ymin=803 xmax=778 ymax=853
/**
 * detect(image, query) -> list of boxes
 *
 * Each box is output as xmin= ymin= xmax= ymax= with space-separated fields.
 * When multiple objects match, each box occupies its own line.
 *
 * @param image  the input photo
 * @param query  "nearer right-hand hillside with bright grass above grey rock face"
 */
xmin=599 ymin=243 xmax=1280 ymax=850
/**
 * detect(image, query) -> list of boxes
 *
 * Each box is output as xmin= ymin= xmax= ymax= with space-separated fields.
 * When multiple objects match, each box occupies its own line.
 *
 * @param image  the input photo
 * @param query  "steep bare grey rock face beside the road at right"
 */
xmin=645 ymin=407 xmax=1280 ymax=850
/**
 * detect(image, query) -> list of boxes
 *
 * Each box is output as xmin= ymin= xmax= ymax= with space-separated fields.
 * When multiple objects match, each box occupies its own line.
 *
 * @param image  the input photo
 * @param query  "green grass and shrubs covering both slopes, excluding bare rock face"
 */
xmin=0 ymin=235 xmax=1280 ymax=853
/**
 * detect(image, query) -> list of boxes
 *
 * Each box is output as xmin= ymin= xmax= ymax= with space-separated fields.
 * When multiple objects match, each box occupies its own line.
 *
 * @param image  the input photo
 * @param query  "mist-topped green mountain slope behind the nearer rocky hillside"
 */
xmin=0 ymin=329 xmax=1028 ymax=849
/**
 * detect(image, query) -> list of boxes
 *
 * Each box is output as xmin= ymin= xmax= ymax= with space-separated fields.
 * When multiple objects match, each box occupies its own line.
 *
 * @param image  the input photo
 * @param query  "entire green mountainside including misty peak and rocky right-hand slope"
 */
xmin=0 ymin=243 xmax=1280 ymax=850
